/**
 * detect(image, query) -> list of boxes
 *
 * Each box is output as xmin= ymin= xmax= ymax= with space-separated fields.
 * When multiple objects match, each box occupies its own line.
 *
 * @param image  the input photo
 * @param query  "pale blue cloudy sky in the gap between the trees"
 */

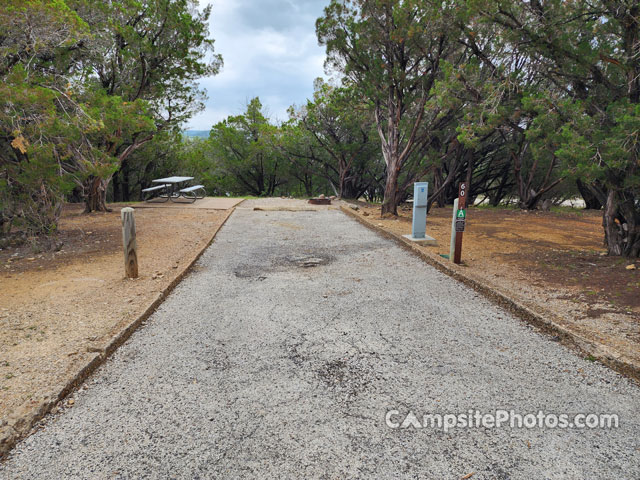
xmin=188 ymin=0 xmax=329 ymax=130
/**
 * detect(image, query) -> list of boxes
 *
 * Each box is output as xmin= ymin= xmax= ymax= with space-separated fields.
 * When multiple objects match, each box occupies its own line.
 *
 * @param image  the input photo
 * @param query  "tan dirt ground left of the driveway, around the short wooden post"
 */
xmin=0 ymin=205 xmax=229 ymax=420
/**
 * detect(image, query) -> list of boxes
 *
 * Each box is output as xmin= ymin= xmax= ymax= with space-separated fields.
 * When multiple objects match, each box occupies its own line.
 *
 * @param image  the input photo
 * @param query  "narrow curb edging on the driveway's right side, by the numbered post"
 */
xmin=340 ymin=204 xmax=640 ymax=383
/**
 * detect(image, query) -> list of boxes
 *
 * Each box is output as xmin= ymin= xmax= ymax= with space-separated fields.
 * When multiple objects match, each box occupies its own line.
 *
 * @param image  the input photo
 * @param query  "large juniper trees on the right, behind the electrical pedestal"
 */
xmin=317 ymin=0 xmax=640 ymax=256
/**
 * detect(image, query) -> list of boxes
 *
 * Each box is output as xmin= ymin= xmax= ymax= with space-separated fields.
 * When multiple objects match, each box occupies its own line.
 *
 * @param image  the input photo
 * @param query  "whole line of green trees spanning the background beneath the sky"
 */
xmin=0 ymin=0 xmax=640 ymax=257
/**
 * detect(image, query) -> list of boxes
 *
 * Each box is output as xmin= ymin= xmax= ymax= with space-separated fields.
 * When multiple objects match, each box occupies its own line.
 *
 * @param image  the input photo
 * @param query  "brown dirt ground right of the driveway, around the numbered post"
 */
xmin=358 ymin=204 xmax=640 ymax=372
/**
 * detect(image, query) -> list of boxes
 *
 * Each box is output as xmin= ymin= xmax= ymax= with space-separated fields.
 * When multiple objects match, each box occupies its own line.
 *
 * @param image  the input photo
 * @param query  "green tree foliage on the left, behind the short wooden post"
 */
xmin=0 ymin=0 xmax=221 ymax=234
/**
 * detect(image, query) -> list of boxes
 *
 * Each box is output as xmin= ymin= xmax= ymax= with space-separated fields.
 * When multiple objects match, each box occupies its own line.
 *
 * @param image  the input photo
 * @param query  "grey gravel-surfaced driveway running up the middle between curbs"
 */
xmin=0 ymin=209 xmax=640 ymax=480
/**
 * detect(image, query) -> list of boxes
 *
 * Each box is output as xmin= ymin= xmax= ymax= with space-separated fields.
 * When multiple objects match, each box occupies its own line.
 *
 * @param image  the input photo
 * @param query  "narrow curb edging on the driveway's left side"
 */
xmin=0 ymin=204 xmax=244 ymax=461
